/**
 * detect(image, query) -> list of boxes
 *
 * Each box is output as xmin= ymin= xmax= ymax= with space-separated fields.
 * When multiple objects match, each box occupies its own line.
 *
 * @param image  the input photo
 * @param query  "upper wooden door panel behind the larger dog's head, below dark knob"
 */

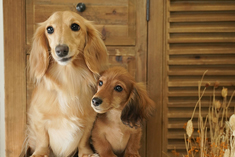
xmin=26 ymin=0 xmax=136 ymax=46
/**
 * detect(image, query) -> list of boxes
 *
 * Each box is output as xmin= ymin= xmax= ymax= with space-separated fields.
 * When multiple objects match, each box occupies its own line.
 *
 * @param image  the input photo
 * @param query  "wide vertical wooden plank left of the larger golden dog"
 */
xmin=3 ymin=0 xmax=26 ymax=157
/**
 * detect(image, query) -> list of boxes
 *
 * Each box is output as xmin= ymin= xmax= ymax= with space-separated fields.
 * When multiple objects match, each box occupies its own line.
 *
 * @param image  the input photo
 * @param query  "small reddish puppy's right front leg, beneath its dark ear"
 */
xmin=124 ymin=128 xmax=142 ymax=157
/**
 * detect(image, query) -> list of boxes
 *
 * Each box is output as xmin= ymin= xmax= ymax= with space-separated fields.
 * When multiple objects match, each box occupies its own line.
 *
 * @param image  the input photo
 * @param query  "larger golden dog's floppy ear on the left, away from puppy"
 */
xmin=29 ymin=24 xmax=49 ymax=81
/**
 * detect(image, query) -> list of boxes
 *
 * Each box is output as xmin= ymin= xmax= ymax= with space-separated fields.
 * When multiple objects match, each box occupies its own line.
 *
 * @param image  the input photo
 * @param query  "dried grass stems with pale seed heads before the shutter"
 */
xmin=167 ymin=71 xmax=235 ymax=157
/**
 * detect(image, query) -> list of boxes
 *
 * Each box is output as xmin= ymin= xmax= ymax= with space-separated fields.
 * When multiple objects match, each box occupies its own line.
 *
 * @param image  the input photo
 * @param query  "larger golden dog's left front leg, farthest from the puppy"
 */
xmin=31 ymin=125 xmax=50 ymax=157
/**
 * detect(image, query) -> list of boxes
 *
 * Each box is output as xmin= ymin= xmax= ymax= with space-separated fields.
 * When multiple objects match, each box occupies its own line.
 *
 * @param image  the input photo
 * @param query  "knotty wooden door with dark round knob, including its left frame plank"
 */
xmin=3 ymin=0 xmax=147 ymax=157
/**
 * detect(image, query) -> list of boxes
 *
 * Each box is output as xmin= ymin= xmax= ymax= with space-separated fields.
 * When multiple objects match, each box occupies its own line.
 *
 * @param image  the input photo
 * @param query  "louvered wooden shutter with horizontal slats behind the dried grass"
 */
xmin=163 ymin=0 xmax=235 ymax=153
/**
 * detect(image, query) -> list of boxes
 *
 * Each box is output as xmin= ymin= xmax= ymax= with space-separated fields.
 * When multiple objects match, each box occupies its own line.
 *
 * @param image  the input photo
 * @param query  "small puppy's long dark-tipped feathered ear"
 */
xmin=121 ymin=83 xmax=155 ymax=127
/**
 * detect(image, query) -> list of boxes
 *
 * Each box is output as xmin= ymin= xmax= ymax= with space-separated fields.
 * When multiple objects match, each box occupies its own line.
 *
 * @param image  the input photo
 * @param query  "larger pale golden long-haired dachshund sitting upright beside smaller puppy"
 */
xmin=27 ymin=11 xmax=107 ymax=157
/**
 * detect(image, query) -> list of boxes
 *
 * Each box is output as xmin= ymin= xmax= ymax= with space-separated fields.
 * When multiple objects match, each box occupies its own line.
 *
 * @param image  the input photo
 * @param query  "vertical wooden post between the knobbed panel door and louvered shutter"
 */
xmin=146 ymin=0 xmax=165 ymax=157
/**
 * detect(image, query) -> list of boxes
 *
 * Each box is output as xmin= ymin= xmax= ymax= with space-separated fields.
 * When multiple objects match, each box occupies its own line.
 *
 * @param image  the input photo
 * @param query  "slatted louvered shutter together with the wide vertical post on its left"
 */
xmin=147 ymin=0 xmax=235 ymax=157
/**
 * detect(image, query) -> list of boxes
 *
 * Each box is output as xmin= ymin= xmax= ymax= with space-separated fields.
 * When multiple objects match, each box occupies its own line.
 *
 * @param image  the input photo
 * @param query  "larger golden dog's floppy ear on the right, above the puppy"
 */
xmin=84 ymin=21 xmax=107 ymax=75
